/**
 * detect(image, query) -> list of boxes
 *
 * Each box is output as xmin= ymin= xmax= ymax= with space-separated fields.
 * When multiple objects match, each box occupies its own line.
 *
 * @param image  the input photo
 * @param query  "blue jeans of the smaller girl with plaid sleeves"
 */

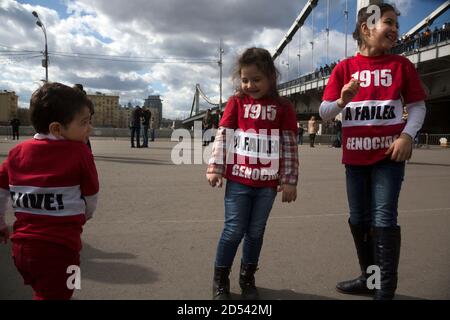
xmin=215 ymin=180 xmax=277 ymax=267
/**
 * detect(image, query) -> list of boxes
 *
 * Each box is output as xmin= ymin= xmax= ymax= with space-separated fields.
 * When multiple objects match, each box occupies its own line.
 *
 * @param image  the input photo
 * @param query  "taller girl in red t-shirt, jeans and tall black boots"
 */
xmin=319 ymin=4 xmax=426 ymax=299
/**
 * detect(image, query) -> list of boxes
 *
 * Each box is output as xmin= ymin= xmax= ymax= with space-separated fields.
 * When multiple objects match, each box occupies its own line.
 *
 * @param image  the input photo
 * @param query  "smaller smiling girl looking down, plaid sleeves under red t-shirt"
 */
xmin=206 ymin=48 xmax=298 ymax=300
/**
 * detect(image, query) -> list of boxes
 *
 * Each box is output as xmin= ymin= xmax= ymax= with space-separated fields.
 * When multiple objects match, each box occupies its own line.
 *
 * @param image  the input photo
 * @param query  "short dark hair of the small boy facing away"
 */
xmin=30 ymin=82 xmax=94 ymax=134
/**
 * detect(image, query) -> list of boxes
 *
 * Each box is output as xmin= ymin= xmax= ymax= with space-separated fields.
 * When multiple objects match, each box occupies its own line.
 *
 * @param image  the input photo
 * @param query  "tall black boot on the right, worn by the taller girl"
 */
xmin=374 ymin=226 xmax=401 ymax=300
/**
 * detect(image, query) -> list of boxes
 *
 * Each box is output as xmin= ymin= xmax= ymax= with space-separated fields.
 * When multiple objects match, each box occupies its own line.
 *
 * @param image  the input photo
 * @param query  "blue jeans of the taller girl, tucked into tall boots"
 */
xmin=345 ymin=159 xmax=405 ymax=227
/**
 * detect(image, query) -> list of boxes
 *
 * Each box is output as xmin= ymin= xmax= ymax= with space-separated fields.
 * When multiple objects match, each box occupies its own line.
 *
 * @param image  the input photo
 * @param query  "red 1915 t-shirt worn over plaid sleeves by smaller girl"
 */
xmin=219 ymin=95 xmax=297 ymax=187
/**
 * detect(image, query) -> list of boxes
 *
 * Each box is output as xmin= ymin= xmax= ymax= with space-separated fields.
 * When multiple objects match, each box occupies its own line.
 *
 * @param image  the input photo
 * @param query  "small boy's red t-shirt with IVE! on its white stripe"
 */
xmin=0 ymin=139 xmax=99 ymax=251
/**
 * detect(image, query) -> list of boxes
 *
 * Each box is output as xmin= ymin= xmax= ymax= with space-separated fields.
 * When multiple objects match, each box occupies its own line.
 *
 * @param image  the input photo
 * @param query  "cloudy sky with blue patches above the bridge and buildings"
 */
xmin=0 ymin=0 xmax=450 ymax=119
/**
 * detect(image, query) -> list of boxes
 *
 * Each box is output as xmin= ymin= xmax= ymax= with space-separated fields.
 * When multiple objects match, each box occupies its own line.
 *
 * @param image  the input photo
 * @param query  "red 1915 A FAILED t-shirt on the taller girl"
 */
xmin=323 ymin=54 xmax=426 ymax=165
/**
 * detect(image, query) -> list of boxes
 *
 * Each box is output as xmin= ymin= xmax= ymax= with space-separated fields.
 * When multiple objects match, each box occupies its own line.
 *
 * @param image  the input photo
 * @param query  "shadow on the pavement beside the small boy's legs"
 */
xmin=81 ymin=243 xmax=158 ymax=284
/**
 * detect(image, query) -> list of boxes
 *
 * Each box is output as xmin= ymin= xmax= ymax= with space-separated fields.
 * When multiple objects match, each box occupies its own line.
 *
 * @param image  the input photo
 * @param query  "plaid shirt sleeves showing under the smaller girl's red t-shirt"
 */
xmin=206 ymin=127 xmax=299 ymax=185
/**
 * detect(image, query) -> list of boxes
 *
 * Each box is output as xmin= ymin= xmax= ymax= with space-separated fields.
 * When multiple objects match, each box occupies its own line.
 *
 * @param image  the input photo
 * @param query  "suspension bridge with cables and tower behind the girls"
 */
xmin=183 ymin=0 xmax=450 ymax=133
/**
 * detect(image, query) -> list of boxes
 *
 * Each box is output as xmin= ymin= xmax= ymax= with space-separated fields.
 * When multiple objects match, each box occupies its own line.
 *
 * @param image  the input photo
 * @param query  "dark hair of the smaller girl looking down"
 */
xmin=232 ymin=47 xmax=280 ymax=97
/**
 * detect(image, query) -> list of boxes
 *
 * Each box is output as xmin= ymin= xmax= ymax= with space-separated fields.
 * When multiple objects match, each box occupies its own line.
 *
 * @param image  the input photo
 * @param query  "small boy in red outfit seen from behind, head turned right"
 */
xmin=0 ymin=83 xmax=99 ymax=300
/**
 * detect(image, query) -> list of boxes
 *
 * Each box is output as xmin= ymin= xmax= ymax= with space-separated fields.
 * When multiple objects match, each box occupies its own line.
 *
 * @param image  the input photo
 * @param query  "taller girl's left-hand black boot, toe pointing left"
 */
xmin=336 ymin=221 xmax=374 ymax=294
